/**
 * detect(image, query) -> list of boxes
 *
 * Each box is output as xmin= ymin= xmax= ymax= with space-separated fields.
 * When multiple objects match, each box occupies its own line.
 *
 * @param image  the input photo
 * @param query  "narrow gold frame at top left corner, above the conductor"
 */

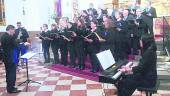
xmin=0 ymin=0 xmax=6 ymax=26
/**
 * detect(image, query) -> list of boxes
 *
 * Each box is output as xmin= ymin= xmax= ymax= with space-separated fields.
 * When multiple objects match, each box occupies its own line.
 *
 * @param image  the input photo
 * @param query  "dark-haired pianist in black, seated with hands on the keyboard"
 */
xmin=117 ymin=34 xmax=157 ymax=96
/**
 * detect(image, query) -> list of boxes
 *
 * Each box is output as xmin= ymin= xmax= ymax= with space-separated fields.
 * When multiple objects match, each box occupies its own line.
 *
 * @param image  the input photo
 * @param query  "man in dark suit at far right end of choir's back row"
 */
xmin=143 ymin=1 xmax=157 ymax=35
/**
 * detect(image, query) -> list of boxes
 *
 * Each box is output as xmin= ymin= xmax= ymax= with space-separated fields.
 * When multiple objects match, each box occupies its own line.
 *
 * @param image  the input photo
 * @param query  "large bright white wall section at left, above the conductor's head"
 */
xmin=0 ymin=0 xmax=54 ymax=32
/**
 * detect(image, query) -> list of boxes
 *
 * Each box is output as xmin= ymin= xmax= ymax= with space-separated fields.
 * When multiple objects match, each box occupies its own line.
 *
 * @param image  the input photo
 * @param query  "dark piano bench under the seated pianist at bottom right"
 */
xmin=137 ymin=80 xmax=160 ymax=96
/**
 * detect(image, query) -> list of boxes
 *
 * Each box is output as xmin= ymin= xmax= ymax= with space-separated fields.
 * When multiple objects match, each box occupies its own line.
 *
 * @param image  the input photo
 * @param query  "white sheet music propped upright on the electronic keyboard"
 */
xmin=96 ymin=50 xmax=115 ymax=70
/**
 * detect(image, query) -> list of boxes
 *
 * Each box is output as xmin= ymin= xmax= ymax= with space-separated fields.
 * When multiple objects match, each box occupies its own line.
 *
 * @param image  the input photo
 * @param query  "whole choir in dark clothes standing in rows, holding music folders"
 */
xmin=38 ymin=2 xmax=156 ymax=72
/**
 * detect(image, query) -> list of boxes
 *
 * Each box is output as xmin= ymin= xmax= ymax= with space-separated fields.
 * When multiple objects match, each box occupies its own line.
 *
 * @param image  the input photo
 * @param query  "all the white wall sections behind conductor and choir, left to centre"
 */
xmin=0 ymin=0 xmax=103 ymax=32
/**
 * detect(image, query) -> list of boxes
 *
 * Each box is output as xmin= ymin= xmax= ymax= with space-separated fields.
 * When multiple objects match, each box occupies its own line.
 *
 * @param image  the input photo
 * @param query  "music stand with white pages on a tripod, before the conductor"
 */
xmin=18 ymin=52 xmax=41 ymax=91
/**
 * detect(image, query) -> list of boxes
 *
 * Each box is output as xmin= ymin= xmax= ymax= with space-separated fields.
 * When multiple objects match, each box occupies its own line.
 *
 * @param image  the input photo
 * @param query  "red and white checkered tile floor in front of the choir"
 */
xmin=0 ymin=58 xmax=170 ymax=96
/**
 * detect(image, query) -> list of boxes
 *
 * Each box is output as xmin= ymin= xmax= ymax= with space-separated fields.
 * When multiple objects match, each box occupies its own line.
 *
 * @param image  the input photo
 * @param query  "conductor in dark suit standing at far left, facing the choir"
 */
xmin=1 ymin=25 xmax=21 ymax=93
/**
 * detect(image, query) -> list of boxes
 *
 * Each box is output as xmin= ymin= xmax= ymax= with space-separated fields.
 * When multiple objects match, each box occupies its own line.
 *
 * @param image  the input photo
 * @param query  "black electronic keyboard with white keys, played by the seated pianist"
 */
xmin=99 ymin=60 xmax=133 ymax=84
